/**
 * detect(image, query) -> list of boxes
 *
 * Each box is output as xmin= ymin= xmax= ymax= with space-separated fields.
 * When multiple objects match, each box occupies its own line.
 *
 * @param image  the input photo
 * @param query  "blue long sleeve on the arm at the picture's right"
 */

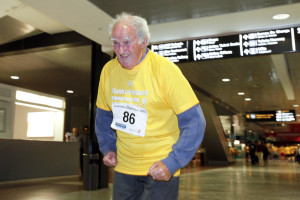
xmin=162 ymin=104 xmax=206 ymax=174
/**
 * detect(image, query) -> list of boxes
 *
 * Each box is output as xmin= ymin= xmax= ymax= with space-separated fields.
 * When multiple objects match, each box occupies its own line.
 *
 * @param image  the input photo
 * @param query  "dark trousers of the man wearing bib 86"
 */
xmin=113 ymin=171 xmax=179 ymax=200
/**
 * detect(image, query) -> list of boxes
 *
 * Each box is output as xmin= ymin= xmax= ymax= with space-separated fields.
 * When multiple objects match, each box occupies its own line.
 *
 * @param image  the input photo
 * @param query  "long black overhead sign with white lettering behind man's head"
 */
xmin=150 ymin=27 xmax=300 ymax=62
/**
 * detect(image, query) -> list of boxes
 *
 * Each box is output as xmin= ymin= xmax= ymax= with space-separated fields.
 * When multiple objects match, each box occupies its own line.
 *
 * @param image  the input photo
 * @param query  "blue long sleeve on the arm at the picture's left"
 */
xmin=95 ymin=108 xmax=117 ymax=155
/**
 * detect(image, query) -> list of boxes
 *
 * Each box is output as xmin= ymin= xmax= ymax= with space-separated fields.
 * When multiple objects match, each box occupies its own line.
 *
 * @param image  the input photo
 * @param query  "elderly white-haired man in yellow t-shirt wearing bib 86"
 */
xmin=95 ymin=13 xmax=205 ymax=200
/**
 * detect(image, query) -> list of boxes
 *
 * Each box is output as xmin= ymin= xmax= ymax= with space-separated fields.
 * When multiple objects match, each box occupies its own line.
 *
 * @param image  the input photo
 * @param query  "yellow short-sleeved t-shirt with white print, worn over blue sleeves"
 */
xmin=96 ymin=50 xmax=199 ymax=176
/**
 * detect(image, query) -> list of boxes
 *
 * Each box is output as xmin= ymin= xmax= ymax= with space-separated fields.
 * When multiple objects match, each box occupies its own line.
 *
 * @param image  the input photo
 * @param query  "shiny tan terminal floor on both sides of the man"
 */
xmin=0 ymin=160 xmax=300 ymax=200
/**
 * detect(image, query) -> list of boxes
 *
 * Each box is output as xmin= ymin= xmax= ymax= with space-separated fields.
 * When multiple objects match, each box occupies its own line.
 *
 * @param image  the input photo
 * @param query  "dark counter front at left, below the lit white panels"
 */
xmin=0 ymin=139 xmax=79 ymax=182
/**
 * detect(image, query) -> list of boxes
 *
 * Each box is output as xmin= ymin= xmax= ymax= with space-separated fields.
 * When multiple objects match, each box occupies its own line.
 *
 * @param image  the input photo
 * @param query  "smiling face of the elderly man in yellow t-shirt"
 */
xmin=112 ymin=23 xmax=146 ymax=69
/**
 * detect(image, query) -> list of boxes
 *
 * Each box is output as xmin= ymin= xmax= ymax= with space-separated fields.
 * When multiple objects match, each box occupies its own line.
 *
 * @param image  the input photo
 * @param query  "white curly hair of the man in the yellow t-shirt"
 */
xmin=109 ymin=12 xmax=150 ymax=44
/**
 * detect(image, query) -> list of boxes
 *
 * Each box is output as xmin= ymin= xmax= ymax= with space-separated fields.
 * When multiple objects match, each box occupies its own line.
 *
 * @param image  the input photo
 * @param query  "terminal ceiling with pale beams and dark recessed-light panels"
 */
xmin=0 ymin=0 xmax=300 ymax=138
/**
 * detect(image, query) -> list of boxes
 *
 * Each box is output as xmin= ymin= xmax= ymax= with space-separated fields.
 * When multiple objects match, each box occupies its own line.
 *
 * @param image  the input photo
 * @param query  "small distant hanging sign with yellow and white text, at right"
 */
xmin=246 ymin=110 xmax=296 ymax=122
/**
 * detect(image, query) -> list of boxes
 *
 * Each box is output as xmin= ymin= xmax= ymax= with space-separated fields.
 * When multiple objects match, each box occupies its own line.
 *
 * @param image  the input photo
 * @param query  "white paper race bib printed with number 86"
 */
xmin=111 ymin=103 xmax=148 ymax=137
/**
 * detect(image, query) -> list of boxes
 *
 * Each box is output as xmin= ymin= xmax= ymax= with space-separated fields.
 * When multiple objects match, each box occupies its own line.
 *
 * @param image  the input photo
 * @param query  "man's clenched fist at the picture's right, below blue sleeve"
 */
xmin=147 ymin=161 xmax=172 ymax=181
